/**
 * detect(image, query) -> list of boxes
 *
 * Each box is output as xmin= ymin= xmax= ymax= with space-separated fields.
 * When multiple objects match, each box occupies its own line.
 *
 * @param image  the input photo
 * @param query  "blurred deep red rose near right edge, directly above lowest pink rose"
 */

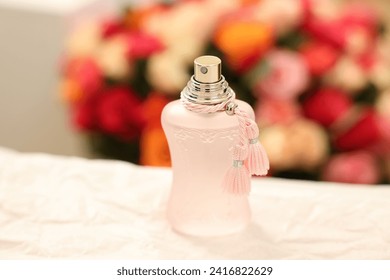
xmin=335 ymin=109 xmax=382 ymax=150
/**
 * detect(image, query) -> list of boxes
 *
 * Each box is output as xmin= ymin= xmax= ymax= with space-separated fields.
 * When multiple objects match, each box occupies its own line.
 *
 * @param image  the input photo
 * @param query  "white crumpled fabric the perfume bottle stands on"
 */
xmin=0 ymin=148 xmax=390 ymax=259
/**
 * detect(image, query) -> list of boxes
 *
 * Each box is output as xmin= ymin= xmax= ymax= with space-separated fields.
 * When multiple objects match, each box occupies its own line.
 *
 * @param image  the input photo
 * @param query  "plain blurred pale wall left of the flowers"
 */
xmin=0 ymin=0 xmax=115 ymax=156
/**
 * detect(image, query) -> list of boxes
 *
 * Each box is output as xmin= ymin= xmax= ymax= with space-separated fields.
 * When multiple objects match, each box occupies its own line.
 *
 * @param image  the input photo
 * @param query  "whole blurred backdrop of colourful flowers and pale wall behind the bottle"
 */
xmin=0 ymin=0 xmax=390 ymax=184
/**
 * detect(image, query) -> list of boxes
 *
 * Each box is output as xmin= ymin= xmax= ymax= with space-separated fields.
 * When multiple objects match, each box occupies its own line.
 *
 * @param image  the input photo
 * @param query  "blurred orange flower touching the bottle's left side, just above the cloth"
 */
xmin=140 ymin=126 xmax=171 ymax=166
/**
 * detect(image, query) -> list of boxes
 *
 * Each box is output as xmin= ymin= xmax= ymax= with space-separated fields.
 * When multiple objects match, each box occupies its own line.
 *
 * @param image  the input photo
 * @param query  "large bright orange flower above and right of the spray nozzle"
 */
xmin=214 ymin=21 xmax=273 ymax=68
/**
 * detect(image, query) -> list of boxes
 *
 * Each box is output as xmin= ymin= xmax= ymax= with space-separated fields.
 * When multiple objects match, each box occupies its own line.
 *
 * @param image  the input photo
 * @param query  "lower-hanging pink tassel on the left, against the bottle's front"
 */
xmin=223 ymin=147 xmax=250 ymax=195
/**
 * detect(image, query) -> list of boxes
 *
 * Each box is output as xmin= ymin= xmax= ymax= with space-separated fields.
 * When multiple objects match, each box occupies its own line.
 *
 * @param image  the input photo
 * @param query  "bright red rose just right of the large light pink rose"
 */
xmin=301 ymin=41 xmax=339 ymax=76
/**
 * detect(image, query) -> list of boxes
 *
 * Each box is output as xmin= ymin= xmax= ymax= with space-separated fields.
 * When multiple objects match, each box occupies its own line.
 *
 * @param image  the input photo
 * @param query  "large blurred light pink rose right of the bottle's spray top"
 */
xmin=255 ymin=50 xmax=309 ymax=100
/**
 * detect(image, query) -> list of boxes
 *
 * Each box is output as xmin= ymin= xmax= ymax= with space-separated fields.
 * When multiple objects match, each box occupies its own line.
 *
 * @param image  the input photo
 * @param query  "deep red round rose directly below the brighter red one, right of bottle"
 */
xmin=303 ymin=88 xmax=352 ymax=127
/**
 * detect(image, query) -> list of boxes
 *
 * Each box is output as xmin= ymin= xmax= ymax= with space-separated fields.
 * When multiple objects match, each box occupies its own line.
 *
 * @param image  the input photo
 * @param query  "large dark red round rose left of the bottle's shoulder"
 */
xmin=96 ymin=87 xmax=144 ymax=140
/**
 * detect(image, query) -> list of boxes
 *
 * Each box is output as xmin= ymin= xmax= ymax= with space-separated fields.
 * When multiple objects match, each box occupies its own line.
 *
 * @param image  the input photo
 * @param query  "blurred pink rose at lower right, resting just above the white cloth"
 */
xmin=323 ymin=151 xmax=380 ymax=184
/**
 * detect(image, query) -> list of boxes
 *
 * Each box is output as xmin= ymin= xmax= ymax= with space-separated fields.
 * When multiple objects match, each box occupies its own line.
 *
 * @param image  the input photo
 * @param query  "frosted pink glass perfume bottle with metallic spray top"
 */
xmin=161 ymin=56 xmax=254 ymax=236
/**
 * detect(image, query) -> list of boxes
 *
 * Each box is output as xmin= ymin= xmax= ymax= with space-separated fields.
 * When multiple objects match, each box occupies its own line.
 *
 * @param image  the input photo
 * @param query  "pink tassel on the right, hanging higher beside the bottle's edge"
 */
xmin=246 ymin=123 xmax=269 ymax=176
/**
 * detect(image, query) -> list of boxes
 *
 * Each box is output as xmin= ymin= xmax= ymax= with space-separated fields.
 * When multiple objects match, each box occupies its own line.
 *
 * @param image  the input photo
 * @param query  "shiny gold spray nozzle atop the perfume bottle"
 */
xmin=194 ymin=55 xmax=221 ymax=84
